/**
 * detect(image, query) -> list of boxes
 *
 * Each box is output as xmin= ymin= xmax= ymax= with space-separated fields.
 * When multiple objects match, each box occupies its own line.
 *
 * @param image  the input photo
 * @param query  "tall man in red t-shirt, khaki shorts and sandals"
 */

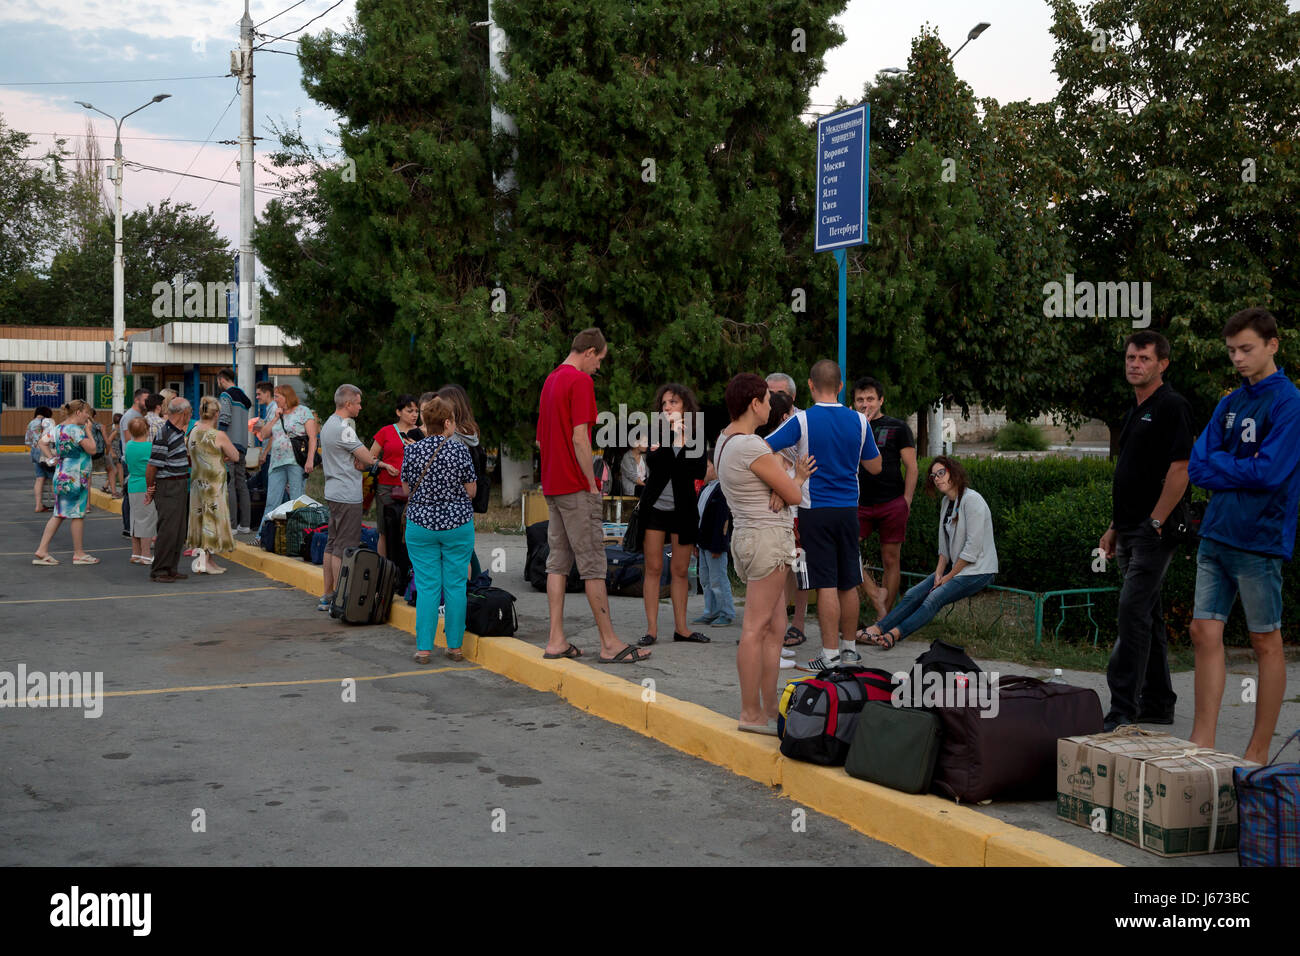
xmin=537 ymin=329 xmax=650 ymax=663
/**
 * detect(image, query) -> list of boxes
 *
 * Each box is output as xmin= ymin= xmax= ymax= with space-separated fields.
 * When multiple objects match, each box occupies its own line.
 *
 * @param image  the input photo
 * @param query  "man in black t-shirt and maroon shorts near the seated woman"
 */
xmin=853 ymin=376 xmax=917 ymax=621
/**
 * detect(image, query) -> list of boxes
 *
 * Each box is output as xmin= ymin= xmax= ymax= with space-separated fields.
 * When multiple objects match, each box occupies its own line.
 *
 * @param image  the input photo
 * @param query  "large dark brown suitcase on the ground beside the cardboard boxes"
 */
xmin=933 ymin=675 xmax=1102 ymax=804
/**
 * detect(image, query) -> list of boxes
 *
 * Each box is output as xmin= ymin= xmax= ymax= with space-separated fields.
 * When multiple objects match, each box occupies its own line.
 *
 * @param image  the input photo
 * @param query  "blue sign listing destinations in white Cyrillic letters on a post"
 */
xmin=813 ymin=103 xmax=871 ymax=252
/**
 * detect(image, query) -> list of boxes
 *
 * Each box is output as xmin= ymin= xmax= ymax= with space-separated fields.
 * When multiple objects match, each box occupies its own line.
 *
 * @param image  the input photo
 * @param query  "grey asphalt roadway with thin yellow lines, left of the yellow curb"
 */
xmin=0 ymin=454 xmax=920 ymax=866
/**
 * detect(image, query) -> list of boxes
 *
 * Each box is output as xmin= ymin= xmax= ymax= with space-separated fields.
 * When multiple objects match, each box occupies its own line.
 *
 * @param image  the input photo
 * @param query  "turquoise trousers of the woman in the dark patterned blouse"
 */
xmin=406 ymin=519 xmax=475 ymax=650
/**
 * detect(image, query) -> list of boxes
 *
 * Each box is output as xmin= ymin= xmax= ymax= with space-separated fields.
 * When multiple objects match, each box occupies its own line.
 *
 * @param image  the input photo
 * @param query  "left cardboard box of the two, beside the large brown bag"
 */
xmin=1057 ymin=724 xmax=1192 ymax=834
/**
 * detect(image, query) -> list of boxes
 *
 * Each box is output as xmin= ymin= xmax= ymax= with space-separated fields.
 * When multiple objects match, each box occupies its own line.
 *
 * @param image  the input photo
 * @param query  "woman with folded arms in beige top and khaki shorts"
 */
xmin=714 ymin=372 xmax=816 ymax=736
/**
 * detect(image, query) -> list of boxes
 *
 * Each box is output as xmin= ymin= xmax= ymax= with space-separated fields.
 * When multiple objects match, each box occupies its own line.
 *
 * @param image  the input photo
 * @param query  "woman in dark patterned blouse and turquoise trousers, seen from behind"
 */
xmin=402 ymin=397 xmax=477 ymax=663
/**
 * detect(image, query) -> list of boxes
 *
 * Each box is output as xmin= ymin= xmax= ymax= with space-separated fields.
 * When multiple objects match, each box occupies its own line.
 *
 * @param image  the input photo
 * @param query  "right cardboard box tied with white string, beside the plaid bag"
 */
xmin=1110 ymin=748 xmax=1255 ymax=856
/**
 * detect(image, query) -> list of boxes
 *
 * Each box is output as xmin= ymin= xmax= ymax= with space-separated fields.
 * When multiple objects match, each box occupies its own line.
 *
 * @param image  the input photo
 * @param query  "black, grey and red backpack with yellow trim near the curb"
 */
xmin=781 ymin=667 xmax=894 ymax=766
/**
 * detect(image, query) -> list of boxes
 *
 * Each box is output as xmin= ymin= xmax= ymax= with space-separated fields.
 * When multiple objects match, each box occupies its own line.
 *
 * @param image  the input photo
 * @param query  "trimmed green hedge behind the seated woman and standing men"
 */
xmin=863 ymin=458 xmax=1300 ymax=646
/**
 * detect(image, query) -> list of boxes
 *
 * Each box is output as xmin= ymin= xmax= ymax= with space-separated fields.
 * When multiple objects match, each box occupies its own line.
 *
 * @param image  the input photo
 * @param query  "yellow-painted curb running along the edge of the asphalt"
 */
xmin=89 ymin=486 xmax=1119 ymax=866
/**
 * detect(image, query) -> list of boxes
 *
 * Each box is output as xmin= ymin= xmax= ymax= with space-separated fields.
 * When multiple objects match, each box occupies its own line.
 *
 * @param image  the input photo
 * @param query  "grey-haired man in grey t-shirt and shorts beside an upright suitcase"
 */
xmin=316 ymin=385 xmax=400 ymax=611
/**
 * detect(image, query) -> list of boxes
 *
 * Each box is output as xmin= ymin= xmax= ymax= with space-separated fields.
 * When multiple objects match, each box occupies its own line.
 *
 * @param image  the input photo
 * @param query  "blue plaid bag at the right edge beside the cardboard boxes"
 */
xmin=1232 ymin=730 xmax=1300 ymax=866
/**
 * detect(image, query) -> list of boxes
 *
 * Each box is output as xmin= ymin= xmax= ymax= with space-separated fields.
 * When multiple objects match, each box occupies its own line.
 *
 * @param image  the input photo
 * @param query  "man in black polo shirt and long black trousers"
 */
xmin=1101 ymin=332 xmax=1195 ymax=731
